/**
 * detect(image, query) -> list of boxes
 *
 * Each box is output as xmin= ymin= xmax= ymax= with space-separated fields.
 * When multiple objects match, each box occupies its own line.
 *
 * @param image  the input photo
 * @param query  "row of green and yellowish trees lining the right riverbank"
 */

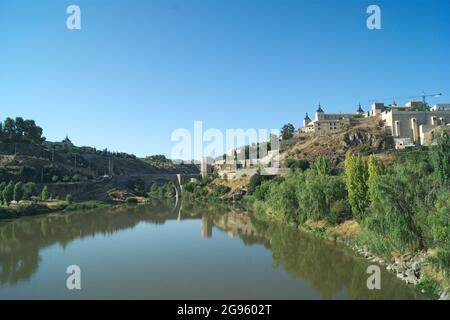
xmin=248 ymin=133 xmax=450 ymax=294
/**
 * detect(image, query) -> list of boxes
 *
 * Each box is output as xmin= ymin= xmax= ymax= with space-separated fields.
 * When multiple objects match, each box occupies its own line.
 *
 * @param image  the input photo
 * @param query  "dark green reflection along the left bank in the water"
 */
xmin=0 ymin=206 xmax=183 ymax=284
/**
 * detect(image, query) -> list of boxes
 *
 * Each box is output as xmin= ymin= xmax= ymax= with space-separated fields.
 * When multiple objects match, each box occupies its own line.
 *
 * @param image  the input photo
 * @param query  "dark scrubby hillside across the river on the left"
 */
xmin=0 ymin=139 xmax=199 ymax=183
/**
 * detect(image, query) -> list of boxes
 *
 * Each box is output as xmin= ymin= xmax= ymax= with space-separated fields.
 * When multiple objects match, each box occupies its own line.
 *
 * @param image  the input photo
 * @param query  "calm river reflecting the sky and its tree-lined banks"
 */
xmin=0 ymin=205 xmax=427 ymax=299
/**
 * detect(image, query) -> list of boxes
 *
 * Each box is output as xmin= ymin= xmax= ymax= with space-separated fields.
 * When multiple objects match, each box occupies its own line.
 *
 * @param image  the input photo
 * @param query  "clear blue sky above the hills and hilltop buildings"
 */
xmin=0 ymin=0 xmax=450 ymax=156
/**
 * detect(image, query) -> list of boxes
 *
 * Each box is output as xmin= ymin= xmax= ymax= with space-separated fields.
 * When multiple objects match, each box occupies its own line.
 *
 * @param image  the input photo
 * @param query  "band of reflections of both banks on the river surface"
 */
xmin=0 ymin=205 xmax=424 ymax=299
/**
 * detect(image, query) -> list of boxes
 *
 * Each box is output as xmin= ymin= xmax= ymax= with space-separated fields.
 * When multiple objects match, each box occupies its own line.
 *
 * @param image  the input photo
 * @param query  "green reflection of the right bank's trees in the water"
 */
xmin=250 ymin=220 xmax=426 ymax=299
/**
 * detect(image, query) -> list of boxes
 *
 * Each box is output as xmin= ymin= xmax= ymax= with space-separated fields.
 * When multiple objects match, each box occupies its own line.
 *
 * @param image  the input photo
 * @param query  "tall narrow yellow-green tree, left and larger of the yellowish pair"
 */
xmin=345 ymin=151 xmax=369 ymax=222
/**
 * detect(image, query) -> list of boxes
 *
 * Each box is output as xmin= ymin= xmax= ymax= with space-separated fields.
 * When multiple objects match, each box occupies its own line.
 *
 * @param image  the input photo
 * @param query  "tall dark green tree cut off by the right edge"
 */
xmin=432 ymin=132 xmax=450 ymax=187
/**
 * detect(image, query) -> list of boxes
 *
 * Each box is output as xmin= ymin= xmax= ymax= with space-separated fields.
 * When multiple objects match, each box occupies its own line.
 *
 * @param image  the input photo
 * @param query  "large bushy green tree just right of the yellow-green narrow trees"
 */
xmin=365 ymin=164 xmax=435 ymax=253
